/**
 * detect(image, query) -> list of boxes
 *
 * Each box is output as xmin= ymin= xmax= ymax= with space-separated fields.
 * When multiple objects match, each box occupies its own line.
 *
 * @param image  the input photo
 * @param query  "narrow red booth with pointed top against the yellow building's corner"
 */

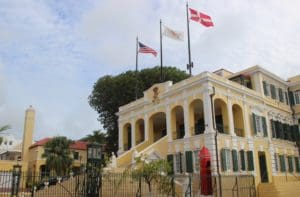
xmin=199 ymin=146 xmax=213 ymax=195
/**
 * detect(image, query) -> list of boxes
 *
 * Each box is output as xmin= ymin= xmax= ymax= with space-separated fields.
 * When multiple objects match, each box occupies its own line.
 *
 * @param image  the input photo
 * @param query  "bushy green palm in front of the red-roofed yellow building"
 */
xmin=42 ymin=136 xmax=73 ymax=176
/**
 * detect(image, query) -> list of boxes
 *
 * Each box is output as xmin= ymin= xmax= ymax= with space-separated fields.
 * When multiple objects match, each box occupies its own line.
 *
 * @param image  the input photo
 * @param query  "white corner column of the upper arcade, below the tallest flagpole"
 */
xmin=203 ymin=89 xmax=214 ymax=133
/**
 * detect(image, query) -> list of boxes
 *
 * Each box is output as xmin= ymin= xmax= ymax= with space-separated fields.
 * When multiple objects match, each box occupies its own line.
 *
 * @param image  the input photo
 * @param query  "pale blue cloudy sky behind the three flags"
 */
xmin=0 ymin=0 xmax=300 ymax=139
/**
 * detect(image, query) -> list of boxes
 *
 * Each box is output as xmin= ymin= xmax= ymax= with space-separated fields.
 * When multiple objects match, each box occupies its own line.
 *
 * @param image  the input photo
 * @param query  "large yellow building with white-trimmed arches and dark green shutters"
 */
xmin=116 ymin=66 xmax=300 ymax=191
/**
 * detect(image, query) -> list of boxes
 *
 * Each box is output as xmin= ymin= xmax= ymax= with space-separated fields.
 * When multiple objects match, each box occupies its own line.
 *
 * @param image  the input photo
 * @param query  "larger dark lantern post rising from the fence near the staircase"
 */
xmin=85 ymin=143 xmax=102 ymax=197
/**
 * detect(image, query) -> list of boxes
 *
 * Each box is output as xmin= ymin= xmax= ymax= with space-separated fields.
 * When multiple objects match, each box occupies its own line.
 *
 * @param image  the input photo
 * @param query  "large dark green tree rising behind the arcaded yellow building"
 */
xmin=89 ymin=67 xmax=188 ymax=152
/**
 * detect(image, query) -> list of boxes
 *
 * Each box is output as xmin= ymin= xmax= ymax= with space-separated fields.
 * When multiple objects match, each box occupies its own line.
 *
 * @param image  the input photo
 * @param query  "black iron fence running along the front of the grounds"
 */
xmin=0 ymin=171 xmax=256 ymax=197
